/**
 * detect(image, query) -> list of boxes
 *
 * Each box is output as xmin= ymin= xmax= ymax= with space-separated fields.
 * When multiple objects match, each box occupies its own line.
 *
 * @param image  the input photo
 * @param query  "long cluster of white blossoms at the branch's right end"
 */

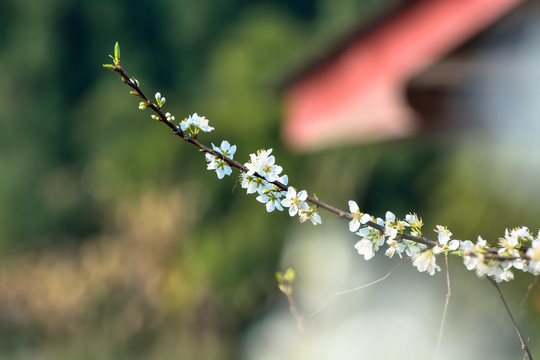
xmin=349 ymin=200 xmax=540 ymax=282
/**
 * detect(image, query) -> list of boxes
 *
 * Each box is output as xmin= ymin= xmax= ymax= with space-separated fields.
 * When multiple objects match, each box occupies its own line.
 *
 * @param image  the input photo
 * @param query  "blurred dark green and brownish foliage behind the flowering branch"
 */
xmin=0 ymin=0 xmax=539 ymax=359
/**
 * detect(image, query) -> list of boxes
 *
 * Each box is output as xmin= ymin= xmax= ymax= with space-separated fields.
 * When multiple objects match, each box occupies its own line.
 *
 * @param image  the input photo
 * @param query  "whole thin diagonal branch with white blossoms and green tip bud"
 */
xmin=103 ymin=43 xmax=540 ymax=358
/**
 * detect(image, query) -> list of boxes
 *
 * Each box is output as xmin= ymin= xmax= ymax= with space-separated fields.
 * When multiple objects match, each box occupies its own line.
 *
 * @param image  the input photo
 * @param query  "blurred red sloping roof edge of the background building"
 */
xmin=283 ymin=0 xmax=522 ymax=150
